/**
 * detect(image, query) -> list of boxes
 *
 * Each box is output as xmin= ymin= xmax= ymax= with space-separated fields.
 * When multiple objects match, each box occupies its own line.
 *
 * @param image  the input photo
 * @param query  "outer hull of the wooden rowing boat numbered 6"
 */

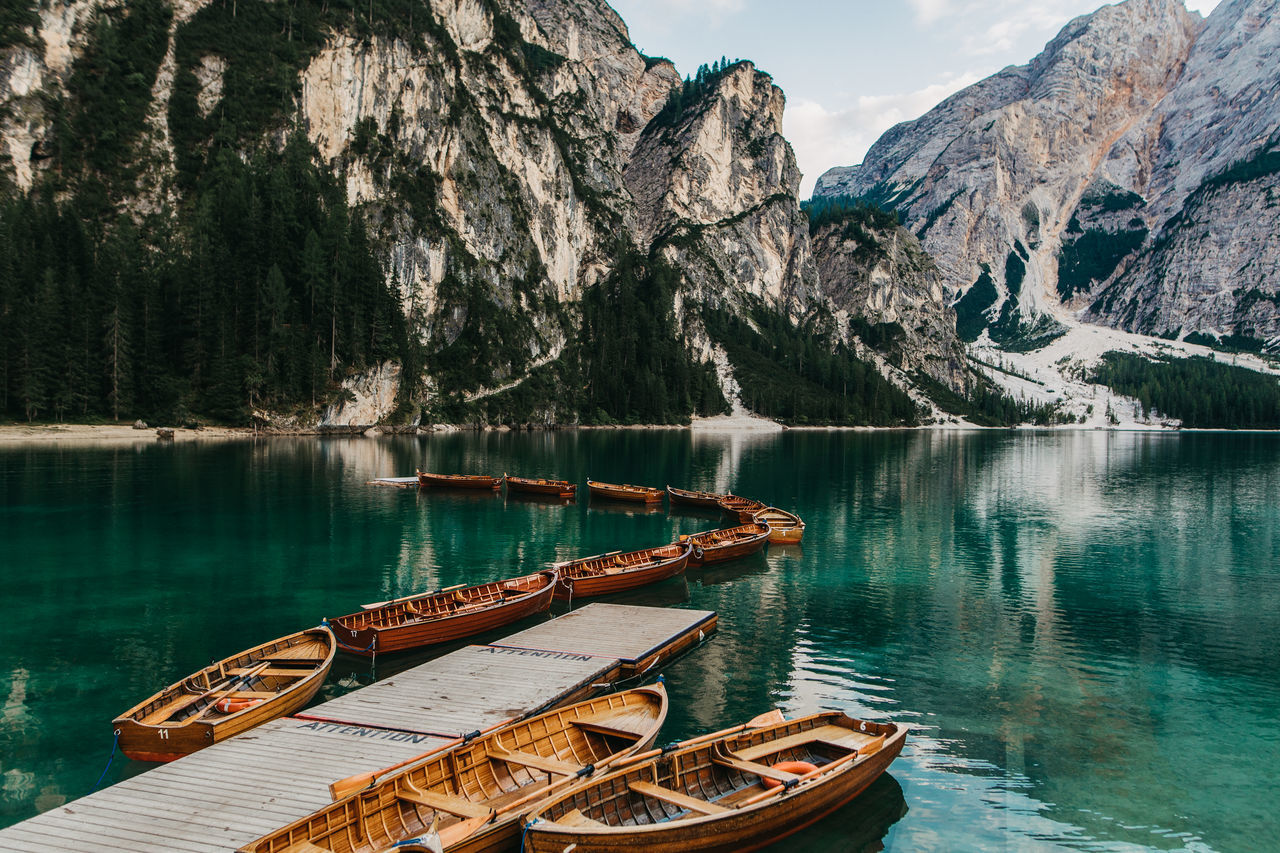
xmin=525 ymin=712 xmax=906 ymax=853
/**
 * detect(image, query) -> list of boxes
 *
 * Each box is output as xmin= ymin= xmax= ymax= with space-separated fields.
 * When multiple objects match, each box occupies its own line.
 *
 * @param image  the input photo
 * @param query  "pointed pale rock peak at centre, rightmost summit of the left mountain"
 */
xmin=626 ymin=63 xmax=820 ymax=318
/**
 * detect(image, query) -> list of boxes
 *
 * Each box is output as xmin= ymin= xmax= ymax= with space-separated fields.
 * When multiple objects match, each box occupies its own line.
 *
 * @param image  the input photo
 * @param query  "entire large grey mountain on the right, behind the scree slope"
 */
xmin=815 ymin=0 xmax=1280 ymax=351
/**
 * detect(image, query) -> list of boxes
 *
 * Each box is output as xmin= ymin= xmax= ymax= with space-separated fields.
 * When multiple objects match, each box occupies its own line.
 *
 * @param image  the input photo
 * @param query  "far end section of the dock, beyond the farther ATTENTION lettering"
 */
xmin=494 ymin=603 xmax=716 ymax=676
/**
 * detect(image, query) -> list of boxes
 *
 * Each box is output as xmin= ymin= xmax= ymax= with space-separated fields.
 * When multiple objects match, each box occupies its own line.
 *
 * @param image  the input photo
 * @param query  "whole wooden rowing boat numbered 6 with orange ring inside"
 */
xmin=525 ymin=711 xmax=906 ymax=853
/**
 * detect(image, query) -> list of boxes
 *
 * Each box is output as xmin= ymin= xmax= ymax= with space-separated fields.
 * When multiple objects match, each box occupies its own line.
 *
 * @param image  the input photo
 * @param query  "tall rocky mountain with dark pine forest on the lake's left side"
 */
xmin=0 ymin=0 xmax=913 ymax=424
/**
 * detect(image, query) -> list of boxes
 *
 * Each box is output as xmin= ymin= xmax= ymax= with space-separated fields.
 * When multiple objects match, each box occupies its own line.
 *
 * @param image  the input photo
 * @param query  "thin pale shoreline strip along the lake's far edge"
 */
xmin=0 ymin=419 xmax=1280 ymax=447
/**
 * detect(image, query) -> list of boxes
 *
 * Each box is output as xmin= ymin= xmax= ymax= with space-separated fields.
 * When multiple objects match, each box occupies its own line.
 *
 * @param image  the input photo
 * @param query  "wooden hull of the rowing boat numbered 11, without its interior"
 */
xmin=111 ymin=628 xmax=337 ymax=762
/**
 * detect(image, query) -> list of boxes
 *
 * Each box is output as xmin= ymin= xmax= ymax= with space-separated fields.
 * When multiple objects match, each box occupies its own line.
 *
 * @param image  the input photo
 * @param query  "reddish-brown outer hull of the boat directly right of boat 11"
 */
xmin=330 ymin=571 xmax=557 ymax=657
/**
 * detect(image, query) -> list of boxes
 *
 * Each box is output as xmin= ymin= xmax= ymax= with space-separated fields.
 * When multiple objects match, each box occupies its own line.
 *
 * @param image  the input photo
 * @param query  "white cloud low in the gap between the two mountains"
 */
xmin=782 ymin=72 xmax=983 ymax=199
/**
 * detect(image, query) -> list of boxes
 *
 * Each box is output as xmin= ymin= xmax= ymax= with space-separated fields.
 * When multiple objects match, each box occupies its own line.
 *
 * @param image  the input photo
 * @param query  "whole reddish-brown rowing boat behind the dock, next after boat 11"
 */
xmin=329 ymin=571 xmax=557 ymax=656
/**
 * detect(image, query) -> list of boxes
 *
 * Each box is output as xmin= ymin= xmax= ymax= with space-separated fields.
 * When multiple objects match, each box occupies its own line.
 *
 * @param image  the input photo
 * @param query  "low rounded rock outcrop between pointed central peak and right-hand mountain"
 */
xmin=813 ymin=213 xmax=972 ymax=392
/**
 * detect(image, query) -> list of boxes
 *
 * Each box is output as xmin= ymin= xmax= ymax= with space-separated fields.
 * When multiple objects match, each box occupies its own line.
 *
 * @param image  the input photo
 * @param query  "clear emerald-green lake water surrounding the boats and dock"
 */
xmin=0 ymin=430 xmax=1280 ymax=850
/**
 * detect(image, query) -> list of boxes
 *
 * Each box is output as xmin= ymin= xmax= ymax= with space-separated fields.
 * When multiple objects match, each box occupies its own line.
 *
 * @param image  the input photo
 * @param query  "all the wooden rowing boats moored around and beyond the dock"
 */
xmin=102 ymin=471 xmax=905 ymax=853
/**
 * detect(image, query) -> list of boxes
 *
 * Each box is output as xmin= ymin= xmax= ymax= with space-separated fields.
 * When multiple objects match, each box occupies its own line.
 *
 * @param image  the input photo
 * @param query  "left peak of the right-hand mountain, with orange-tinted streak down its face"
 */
xmin=817 ymin=0 xmax=1199 ymax=338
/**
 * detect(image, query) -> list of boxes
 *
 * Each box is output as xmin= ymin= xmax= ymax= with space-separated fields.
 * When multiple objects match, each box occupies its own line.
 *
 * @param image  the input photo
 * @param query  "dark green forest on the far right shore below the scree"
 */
xmin=1091 ymin=352 xmax=1280 ymax=429
